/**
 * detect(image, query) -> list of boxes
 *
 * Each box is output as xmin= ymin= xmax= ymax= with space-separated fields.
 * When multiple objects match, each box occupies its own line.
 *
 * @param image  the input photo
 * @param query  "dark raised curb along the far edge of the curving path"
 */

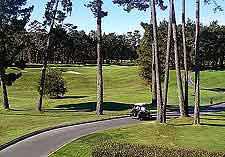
xmin=0 ymin=115 xmax=129 ymax=151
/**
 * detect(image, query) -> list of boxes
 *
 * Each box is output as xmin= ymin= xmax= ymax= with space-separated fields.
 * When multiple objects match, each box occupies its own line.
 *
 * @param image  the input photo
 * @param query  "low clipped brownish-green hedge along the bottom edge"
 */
xmin=92 ymin=141 xmax=225 ymax=157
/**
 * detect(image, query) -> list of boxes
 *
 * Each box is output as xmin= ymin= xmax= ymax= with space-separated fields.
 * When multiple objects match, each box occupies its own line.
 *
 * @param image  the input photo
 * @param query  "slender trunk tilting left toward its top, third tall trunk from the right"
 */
xmin=172 ymin=0 xmax=185 ymax=117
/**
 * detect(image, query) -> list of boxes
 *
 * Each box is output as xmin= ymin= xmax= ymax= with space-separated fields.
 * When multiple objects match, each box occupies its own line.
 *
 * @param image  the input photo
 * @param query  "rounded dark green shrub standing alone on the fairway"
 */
xmin=38 ymin=68 xmax=68 ymax=98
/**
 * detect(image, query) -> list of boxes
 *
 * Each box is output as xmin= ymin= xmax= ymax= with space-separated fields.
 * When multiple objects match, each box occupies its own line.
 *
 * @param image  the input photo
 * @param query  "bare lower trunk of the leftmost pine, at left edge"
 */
xmin=0 ymin=70 xmax=9 ymax=110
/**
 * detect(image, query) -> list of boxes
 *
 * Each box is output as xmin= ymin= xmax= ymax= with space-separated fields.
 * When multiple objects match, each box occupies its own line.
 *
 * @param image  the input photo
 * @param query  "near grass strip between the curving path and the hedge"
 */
xmin=51 ymin=112 xmax=225 ymax=157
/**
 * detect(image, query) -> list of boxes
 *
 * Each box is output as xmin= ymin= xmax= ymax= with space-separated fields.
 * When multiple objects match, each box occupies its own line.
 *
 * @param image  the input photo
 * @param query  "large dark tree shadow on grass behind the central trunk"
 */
xmin=50 ymin=102 xmax=131 ymax=112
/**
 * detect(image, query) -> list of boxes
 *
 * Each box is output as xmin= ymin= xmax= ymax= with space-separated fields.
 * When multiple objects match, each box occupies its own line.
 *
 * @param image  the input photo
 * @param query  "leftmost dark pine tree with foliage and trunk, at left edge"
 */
xmin=0 ymin=0 xmax=33 ymax=109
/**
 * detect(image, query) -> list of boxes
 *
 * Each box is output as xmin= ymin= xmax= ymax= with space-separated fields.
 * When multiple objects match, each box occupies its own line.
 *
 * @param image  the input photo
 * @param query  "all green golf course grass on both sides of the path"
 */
xmin=0 ymin=65 xmax=225 ymax=157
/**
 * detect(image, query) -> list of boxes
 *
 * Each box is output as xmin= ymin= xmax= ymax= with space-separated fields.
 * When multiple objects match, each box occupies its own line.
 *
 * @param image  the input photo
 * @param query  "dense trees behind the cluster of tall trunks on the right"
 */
xmin=137 ymin=19 xmax=225 ymax=84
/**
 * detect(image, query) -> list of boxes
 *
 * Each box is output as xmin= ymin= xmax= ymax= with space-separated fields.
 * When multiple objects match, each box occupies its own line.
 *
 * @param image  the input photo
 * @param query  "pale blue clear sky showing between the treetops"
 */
xmin=27 ymin=0 xmax=225 ymax=34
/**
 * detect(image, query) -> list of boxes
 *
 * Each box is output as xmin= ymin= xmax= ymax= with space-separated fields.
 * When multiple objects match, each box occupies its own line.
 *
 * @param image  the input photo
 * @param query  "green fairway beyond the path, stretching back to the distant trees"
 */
xmin=0 ymin=65 xmax=225 ymax=144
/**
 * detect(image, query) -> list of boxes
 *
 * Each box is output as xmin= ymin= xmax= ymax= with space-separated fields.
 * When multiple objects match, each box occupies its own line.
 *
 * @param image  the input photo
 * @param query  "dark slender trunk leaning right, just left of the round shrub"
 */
xmin=37 ymin=0 xmax=59 ymax=112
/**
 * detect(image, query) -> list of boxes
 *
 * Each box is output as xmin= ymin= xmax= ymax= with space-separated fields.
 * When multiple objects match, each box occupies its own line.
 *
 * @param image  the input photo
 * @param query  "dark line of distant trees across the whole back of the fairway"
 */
xmin=23 ymin=19 xmax=225 ymax=68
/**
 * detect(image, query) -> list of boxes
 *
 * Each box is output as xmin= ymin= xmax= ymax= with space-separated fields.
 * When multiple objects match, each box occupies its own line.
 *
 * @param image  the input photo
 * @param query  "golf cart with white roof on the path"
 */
xmin=130 ymin=103 xmax=151 ymax=120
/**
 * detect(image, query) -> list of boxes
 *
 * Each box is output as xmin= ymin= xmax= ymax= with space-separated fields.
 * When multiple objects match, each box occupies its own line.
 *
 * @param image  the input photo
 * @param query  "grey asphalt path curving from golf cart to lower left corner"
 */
xmin=0 ymin=117 xmax=140 ymax=157
